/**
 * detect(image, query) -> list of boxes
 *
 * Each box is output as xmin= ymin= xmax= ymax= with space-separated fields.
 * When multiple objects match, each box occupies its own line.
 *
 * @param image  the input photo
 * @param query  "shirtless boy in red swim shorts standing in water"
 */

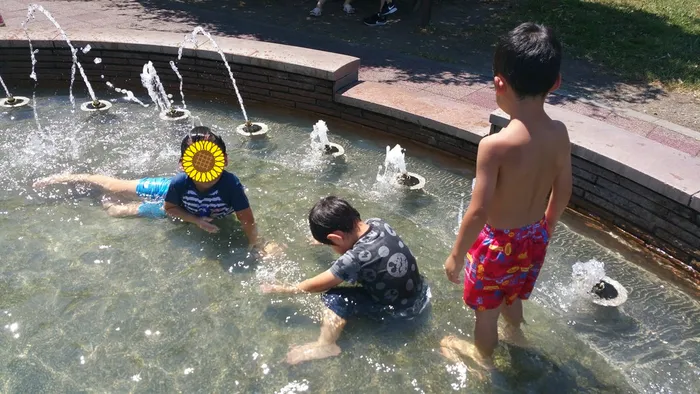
xmin=441 ymin=23 xmax=572 ymax=367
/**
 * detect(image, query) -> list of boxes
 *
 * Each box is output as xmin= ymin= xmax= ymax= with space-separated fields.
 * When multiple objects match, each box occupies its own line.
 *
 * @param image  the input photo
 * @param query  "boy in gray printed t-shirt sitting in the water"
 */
xmin=262 ymin=196 xmax=430 ymax=364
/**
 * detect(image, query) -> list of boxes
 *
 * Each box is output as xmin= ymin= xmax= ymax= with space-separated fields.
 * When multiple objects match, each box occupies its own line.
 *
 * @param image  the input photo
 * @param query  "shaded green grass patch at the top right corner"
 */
xmin=489 ymin=0 xmax=700 ymax=92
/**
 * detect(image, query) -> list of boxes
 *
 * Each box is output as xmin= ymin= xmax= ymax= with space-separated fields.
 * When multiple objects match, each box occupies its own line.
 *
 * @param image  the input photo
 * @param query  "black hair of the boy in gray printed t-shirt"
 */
xmin=309 ymin=196 xmax=362 ymax=245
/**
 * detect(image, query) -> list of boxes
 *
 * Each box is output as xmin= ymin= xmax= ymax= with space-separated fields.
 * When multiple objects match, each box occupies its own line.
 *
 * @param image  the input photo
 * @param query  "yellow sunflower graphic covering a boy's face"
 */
xmin=182 ymin=141 xmax=224 ymax=182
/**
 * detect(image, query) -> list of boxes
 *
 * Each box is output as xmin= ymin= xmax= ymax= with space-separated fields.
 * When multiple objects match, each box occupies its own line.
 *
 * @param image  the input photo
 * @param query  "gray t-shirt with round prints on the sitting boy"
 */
xmin=330 ymin=219 xmax=423 ymax=308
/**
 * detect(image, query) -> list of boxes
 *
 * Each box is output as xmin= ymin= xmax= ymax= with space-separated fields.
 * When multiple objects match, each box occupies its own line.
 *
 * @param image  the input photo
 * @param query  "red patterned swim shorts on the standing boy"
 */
xmin=464 ymin=218 xmax=549 ymax=311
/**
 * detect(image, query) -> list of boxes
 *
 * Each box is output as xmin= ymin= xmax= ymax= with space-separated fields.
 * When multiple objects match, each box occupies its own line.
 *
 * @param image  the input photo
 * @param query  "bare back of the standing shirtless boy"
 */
xmin=478 ymin=113 xmax=571 ymax=229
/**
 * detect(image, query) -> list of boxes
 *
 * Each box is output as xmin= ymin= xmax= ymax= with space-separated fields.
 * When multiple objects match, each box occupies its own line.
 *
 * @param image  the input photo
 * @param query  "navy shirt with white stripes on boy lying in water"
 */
xmin=165 ymin=171 xmax=250 ymax=218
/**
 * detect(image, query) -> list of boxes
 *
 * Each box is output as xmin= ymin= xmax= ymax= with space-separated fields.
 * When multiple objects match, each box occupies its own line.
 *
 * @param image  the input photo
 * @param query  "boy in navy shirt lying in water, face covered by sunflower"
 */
xmin=34 ymin=126 xmax=274 ymax=254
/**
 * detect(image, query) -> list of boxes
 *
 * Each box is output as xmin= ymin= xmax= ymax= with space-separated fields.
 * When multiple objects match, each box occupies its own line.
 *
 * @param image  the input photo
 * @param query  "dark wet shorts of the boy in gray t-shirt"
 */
xmin=321 ymin=282 xmax=431 ymax=320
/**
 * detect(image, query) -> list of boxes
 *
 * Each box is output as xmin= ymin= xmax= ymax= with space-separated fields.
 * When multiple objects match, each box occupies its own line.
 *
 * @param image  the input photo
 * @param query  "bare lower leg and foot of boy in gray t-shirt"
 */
xmin=287 ymin=308 xmax=347 ymax=365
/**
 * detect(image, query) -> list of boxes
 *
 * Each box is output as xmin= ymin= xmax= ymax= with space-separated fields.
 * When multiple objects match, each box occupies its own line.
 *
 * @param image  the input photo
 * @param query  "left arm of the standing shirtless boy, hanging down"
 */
xmin=445 ymin=137 xmax=500 ymax=283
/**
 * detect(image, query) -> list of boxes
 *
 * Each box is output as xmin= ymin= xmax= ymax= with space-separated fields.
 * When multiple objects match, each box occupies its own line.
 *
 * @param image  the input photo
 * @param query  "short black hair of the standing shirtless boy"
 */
xmin=493 ymin=22 xmax=561 ymax=99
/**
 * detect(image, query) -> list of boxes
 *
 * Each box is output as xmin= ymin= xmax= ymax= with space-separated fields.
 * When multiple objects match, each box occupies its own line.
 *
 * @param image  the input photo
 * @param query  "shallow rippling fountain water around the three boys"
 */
xmin=0 ymin=95 xmax=700 ymax=393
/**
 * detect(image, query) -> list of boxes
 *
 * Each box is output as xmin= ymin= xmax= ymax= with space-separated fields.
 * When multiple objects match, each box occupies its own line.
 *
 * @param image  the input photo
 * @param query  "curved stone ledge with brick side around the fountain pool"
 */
xmin=0 ymin=29 xmax=700 ymax=281
